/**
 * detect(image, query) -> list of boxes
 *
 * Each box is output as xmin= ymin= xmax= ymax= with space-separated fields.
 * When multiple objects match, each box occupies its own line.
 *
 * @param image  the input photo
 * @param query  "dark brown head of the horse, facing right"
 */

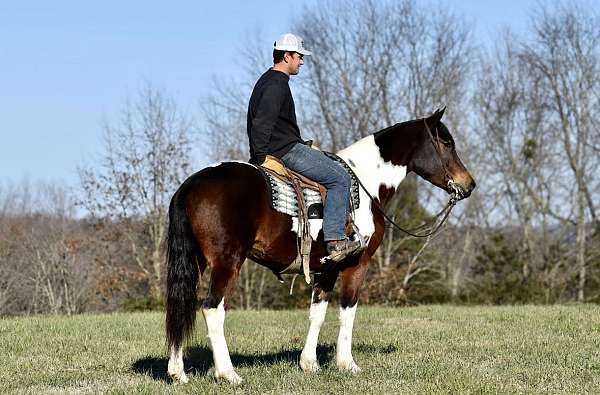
xmin=407 ymin=107 xmax=475 ymax=199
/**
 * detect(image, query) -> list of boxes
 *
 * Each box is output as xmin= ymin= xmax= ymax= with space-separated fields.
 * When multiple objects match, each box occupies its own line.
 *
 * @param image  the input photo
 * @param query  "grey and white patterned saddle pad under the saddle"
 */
xmin=258 ymin=153 xmax=360 ymax=219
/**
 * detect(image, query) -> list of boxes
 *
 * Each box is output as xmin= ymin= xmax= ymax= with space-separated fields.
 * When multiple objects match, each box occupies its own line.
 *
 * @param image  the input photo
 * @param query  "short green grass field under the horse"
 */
xmin=0 ymin=305 xmax=600 ymax=394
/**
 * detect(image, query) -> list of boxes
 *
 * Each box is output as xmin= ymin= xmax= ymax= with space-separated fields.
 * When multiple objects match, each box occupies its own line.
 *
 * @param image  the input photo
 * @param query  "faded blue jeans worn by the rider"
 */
xmin=281 ymin=143 xmax=352 ymax=241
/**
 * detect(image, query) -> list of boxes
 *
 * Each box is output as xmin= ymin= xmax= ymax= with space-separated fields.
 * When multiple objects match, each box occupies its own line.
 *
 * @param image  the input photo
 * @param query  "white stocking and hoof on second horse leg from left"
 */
xmin=202 ymin=299 xmax=242 ymax=384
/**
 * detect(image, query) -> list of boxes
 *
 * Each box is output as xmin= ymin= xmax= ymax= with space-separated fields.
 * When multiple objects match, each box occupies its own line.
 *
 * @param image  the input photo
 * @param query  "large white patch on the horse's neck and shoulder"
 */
xmin=338 ymin=135 xmax=406 ymax=237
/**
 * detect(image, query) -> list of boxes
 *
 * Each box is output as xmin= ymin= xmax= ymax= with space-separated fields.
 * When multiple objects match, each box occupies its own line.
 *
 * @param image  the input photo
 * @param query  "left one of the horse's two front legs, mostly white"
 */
xmin=300 ymin=273 xmax=337 ymax=372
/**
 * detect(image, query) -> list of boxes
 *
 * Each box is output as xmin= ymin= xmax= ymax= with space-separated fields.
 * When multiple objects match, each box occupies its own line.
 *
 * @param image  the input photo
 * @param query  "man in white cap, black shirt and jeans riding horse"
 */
xmin=247 ymin=33 xmax=360 ymax=262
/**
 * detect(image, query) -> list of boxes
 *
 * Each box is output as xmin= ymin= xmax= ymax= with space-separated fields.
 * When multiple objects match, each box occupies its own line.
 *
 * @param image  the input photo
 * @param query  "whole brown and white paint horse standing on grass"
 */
xmin=166 ymin=108 xmax=475 ymax=384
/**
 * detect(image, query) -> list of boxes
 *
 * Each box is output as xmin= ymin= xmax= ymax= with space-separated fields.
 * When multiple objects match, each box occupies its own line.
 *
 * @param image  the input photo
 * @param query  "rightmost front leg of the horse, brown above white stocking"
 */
xmin=336 ymin=254 xmax=369 ymax=373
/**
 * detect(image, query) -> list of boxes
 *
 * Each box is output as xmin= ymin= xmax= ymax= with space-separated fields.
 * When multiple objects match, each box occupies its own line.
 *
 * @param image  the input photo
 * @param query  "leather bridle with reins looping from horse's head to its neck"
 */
xmin=351 ymin=118 xmax=464 ymax=237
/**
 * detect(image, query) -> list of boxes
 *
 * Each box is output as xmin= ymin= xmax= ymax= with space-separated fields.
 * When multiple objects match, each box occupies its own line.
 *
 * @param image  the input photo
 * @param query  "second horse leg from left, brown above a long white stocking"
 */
xmin=202 ymin=256 xmax=244 ymax=384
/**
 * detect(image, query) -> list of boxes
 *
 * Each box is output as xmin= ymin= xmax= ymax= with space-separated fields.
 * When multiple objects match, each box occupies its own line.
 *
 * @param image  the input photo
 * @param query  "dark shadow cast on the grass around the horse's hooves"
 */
xmin=131 ymin=344 xmax=397 ymax=382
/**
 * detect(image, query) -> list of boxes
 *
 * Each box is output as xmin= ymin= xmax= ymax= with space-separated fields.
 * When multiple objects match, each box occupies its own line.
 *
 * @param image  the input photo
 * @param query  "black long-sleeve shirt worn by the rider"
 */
xmin=246 ymin=69 xmax=302 ymax=164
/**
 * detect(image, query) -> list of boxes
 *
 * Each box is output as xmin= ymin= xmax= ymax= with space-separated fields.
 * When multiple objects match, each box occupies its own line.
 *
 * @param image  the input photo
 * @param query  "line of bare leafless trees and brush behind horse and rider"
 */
xmin=0 ymin=0 xmax=600 ymax=314
